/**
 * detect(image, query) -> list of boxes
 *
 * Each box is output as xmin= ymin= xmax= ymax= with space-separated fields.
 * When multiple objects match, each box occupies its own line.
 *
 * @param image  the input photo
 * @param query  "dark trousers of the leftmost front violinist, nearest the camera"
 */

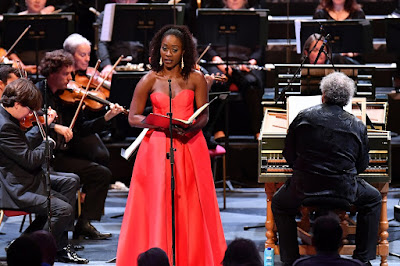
xmin=23 ymin=172 xmax=79 ymax=249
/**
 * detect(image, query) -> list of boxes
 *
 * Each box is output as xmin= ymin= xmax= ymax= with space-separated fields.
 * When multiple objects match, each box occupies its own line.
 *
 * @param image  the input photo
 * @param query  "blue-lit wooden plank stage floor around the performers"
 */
xmin=0 ymin=188 xmax=400 ymax=266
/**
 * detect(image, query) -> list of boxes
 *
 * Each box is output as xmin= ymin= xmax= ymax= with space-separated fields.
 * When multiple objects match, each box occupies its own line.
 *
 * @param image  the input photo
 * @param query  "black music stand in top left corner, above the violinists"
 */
xmin=2 ymin=13 xmax=75 ymax=77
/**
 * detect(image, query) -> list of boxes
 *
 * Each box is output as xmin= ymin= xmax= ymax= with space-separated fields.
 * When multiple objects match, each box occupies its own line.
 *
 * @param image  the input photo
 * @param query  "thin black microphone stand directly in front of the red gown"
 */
xmin=167 ymin=79 xmax=175 ymax=266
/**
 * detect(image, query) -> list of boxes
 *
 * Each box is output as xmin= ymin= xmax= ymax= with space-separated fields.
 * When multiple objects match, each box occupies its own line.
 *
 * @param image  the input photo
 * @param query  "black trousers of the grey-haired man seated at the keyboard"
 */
xmin=272 ymin=178 xmax=382 ymax=264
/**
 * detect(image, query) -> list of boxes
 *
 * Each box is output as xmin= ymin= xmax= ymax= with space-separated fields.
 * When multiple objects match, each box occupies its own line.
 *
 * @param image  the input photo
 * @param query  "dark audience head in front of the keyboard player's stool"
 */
xmin=313 ymin=213 xmax=343 ymax=252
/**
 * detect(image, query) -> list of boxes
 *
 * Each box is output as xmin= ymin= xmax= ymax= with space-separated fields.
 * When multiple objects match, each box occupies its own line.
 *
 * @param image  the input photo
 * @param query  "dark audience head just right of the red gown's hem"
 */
xmin=222 ymin=238 xmax=262 ymax=266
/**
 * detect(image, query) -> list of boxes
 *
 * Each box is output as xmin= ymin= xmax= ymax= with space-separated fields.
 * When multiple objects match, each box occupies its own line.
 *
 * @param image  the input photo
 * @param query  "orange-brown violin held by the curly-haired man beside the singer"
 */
xmin=59 ymin=81 xmax=129 ymax=115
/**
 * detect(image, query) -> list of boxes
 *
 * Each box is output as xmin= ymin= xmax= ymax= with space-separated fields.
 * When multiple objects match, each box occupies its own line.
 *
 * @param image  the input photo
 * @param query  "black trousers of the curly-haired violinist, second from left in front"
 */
xmin=52 ymin=152 xmax=112 ymax=221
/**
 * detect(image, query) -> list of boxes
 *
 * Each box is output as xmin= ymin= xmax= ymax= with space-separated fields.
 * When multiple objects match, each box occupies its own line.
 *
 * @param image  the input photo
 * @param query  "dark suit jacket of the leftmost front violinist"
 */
xmin=0 ymin=106 xmax=53 ymax=209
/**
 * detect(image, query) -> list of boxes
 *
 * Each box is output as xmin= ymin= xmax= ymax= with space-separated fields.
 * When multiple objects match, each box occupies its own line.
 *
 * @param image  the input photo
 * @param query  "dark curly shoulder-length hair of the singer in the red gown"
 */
xmin=150 ymin=25 xmax=197 ymax=79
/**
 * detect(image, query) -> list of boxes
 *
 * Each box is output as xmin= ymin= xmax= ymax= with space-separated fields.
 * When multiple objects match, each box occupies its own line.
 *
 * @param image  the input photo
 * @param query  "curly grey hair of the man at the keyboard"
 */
xmin=320 ymin=72 xmax=356 ymax=106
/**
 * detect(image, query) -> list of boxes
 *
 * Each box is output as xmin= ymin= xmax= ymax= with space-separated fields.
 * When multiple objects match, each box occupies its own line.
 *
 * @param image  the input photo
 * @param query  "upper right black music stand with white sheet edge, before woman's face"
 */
xmin=296 ymin=19 xmax=373 ymax=53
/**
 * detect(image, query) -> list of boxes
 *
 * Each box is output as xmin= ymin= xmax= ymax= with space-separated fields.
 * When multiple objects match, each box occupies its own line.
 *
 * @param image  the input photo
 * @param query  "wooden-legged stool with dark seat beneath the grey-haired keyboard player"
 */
xmin=297 ymin=194 xmax=356 ymax=249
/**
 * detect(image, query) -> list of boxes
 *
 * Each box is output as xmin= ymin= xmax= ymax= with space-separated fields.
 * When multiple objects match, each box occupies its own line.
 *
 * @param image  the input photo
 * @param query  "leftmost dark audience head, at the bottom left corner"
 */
xmin=7 ymin=235 xmax=42 ymax=266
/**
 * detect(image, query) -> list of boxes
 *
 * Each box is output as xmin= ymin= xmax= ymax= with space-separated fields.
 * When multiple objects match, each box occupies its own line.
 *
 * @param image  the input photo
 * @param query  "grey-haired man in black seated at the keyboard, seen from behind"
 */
xmin=272 ymin=72 xmax=382 ymax=265
